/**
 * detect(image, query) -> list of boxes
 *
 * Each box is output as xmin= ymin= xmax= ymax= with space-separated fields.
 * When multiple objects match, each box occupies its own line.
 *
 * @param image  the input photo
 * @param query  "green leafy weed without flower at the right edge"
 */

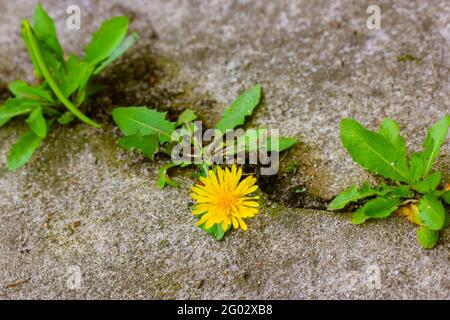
xmin=329 ymin=114 xmax=450 ymax=249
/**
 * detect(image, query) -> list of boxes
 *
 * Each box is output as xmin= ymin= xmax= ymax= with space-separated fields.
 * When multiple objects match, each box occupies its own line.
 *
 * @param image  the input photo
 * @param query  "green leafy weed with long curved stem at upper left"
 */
xmin=0 ymin=4 xmax=138 ymax=170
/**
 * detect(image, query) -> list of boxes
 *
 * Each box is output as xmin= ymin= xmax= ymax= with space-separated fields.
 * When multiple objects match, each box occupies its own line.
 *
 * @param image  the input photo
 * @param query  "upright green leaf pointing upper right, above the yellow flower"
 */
xmin=216 ymin=84 xmax=261 ymax=134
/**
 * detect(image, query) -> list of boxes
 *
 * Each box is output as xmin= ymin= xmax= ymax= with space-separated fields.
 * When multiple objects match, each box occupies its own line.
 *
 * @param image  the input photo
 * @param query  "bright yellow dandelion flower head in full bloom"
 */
xmin=191 ymin=165 xmax=259 ymax=232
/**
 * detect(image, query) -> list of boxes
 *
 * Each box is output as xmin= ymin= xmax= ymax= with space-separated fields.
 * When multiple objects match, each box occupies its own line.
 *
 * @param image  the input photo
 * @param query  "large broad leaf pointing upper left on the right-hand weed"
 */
xmin=341 ymin=119 xmax=410 ymax=182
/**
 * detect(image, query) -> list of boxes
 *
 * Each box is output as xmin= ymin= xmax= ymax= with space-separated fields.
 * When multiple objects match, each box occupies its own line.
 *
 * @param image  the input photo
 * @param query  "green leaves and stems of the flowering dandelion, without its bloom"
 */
xmin=112 ymin=85 xmax=296 ymax=188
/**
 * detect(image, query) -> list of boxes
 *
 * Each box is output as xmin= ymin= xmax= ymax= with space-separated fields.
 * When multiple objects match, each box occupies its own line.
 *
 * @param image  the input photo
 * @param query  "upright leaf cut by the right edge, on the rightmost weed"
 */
xmin=420 ymin=114 xmax=450 ymax=177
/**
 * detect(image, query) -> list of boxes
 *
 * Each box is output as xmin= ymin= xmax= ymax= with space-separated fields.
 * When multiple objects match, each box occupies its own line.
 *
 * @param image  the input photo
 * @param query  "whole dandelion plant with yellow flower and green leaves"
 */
xmin=112 ymin=85 xmax=297 ymax=240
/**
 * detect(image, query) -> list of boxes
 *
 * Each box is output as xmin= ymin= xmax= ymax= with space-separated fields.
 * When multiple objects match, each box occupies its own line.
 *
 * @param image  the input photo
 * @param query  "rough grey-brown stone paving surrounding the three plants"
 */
xmin=0 ymin=0 xmax=450 ymax=299
